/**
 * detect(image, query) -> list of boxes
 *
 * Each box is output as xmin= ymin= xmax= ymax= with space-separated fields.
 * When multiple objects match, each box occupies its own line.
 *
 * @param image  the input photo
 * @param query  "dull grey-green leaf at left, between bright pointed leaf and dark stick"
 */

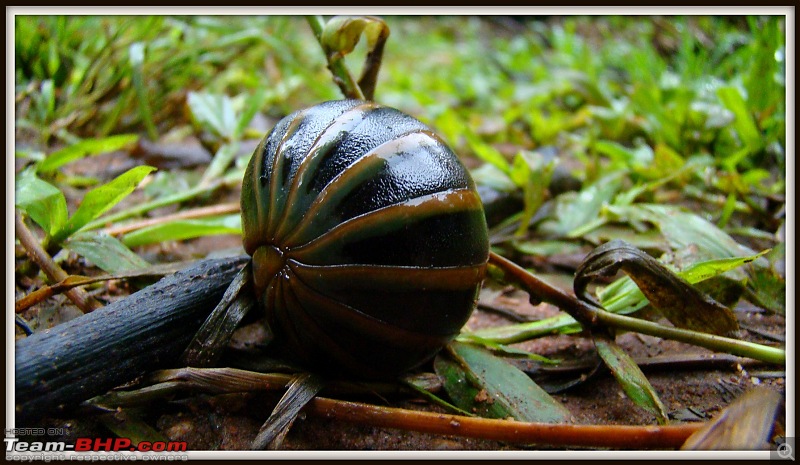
xmin=64 ymin=231 xmax=150 ymax=274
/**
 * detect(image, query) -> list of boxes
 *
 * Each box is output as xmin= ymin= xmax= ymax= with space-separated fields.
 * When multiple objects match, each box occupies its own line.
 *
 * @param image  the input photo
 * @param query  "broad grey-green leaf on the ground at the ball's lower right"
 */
xmin=445 ymin=342 xmax=571 ymax=423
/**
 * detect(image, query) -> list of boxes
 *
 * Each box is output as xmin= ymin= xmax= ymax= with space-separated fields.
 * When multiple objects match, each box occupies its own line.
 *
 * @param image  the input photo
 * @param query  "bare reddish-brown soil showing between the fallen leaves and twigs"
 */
xmin=16 ymin=157 xmax=785 ymax=451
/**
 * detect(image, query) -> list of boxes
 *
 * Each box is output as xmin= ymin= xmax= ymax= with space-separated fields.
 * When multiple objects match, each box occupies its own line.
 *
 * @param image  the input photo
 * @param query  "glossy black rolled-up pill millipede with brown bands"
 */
xmin=242 ymin=100 xmax=489 ymax=378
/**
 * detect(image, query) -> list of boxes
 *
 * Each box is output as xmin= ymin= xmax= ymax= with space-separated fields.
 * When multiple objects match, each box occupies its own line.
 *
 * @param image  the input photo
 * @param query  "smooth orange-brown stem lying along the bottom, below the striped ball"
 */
xmin=305 ymin=397 xmax=705 ymax=449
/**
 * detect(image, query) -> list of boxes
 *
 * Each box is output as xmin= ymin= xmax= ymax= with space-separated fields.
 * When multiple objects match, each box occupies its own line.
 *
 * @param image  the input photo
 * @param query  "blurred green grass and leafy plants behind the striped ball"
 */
xmin=14 ymin=16 xmax=786 ymax=312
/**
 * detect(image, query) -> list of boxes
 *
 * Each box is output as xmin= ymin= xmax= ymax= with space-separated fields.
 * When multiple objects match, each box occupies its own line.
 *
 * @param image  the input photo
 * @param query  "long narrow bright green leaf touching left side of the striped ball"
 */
xmin=122 ymin=215 xmax=242 ymax=247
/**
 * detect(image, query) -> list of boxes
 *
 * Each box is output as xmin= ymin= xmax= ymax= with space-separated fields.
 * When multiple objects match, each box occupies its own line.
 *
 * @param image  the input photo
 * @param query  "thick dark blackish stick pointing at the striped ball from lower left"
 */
xmin=14 ymin=256 xmax=247 ymax=426
